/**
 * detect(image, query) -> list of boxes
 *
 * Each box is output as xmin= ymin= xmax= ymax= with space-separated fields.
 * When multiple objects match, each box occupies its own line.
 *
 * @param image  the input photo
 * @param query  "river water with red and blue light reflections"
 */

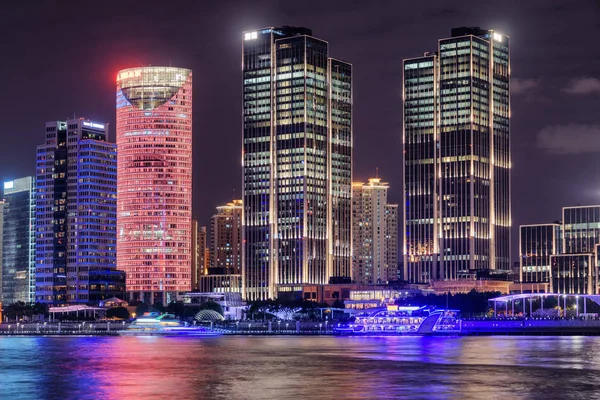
xmin=0 ymin=336 xmax=600 ymax=400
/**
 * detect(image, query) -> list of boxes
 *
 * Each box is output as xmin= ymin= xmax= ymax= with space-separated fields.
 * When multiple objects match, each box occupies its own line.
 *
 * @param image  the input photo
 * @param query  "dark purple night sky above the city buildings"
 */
xmin=0 ymin=0 xmax=600 ymax=259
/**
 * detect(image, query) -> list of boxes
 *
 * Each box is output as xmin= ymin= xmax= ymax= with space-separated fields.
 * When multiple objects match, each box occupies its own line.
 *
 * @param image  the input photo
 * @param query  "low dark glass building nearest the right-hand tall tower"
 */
xmin=519 ymin=224 xmax=563 ymax=283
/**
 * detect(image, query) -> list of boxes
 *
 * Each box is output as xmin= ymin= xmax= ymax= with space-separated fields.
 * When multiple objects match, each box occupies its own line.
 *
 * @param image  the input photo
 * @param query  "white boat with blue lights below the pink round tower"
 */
xmin=119 ymin=312 xmax=221 ymax=336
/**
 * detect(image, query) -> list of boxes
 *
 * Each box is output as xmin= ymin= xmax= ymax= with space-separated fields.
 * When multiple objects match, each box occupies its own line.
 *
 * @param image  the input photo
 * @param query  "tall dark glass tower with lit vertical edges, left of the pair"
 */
xmin=242 ymin=26 xmax=352 ymax=300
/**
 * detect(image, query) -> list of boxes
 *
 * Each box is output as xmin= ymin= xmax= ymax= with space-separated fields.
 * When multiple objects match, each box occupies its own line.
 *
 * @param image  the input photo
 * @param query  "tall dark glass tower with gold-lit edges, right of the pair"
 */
xmin=403 ymin=28 xmax=511 ymax=283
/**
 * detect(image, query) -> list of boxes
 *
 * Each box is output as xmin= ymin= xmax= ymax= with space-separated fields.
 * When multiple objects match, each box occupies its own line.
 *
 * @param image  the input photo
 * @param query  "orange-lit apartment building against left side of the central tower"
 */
xmin=200 ymin=200 xmax=243 ymax=292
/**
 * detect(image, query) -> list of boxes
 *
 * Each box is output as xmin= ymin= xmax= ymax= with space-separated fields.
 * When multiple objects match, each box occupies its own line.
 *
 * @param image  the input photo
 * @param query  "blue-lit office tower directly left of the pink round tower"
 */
xmin=35 ymin=118 xmax=124 ymax=304
